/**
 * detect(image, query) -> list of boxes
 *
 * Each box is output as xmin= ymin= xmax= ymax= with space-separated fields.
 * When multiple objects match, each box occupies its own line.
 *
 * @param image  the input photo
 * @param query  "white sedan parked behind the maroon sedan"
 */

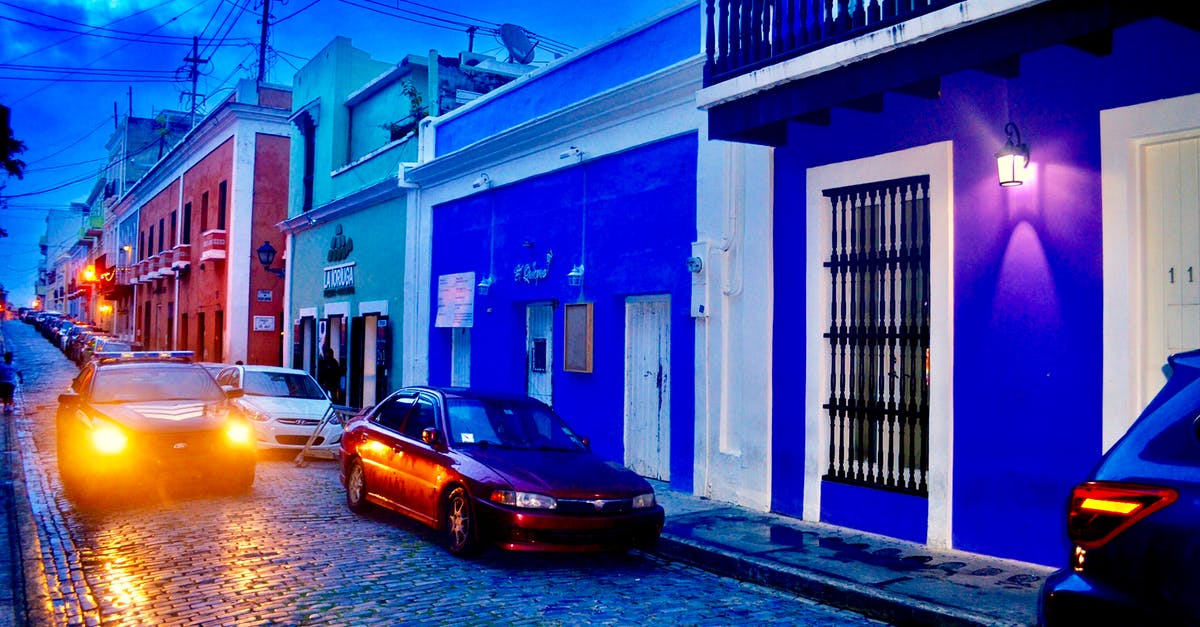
xmin=217 ymin=365 xmax=342 ymax=459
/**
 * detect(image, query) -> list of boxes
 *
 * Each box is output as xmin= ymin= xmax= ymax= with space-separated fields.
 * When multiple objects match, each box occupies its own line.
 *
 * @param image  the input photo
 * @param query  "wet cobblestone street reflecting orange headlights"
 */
xmin=4 ymin=322 xmax=869 ymax=625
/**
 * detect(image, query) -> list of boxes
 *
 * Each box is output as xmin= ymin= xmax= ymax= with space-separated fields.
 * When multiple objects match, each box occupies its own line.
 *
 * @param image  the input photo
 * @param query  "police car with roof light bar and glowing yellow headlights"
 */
xmin=56 ymin=351 xmax=256 ymax=503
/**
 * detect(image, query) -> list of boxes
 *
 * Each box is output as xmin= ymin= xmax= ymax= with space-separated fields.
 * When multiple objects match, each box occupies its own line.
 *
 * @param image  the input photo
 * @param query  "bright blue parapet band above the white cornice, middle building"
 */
xmin=437 ymin=2 xmax=701 ymax=155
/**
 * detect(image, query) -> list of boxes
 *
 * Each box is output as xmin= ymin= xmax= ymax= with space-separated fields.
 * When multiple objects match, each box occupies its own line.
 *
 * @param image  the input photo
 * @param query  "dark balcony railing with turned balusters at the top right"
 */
xmin=704 ymin=0 xmax=958 ymax=86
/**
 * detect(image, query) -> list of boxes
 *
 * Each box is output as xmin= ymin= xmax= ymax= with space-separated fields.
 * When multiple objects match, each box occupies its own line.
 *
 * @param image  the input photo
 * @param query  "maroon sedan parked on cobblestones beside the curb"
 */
xmin=342 ymin=387 xmax=664 ymax=555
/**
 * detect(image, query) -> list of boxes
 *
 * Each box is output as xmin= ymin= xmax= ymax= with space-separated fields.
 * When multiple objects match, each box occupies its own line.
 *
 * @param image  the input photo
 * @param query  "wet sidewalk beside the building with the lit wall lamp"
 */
xmin=652 ymin=482 xmax=1054 ymax=625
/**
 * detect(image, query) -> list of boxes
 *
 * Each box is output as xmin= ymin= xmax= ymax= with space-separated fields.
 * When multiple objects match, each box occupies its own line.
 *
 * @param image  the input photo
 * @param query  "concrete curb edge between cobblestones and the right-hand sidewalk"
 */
xmin=653 ymin=532 xmax=1019 ymax=627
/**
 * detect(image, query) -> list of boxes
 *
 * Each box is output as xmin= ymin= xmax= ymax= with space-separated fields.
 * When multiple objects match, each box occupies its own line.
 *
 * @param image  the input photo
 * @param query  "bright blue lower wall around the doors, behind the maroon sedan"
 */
xmin=430 ymin=135 xmax=697 ymax=491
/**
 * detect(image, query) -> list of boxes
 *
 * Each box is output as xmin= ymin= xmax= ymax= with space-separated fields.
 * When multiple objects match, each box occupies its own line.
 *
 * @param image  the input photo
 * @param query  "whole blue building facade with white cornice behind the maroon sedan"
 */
xmin=406 ymin=6 xmax=703 ymax=490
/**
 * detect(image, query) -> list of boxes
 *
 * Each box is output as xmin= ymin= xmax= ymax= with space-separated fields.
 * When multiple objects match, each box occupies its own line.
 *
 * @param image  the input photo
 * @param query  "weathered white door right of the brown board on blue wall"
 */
xmin=625 ymin=294 xmax=671 ymax=480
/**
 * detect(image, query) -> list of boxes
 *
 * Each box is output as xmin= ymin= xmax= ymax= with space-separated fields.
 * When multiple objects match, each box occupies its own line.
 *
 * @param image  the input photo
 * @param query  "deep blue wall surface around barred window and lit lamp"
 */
xmin=773 ymin=19 xmax=1200 ymax=565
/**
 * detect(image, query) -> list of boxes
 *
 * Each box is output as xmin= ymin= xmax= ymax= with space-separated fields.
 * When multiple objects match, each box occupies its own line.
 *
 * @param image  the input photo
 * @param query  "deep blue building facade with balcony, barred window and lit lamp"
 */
xmin=697 ymin=1 xmax=1200 ymax=565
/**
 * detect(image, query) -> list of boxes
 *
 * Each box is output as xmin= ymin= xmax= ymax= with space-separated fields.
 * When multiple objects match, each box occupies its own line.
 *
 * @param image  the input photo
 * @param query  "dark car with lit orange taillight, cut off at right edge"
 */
xmin=1039 ymin=351 xmax=1200 ymax=626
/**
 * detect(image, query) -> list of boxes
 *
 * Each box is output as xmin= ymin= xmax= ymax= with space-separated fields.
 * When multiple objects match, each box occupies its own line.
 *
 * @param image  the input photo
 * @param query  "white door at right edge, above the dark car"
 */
xmin=1142 ymin=136 xmax=1200 ymax=400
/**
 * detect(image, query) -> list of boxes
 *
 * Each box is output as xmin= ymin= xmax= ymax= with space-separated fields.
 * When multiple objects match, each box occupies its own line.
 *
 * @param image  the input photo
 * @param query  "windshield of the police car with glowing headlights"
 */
xmin=91 ymin=364 xmax=224 ymax=402
